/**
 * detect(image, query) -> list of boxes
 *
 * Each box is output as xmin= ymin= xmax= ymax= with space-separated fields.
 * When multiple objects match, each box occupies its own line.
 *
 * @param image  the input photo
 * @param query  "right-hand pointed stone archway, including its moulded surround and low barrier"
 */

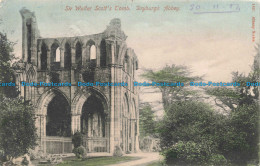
xmin=72 ymin=89 xmax=110 ymax=153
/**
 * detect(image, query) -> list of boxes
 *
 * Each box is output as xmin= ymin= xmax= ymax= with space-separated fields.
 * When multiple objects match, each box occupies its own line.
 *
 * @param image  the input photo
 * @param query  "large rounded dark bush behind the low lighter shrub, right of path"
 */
xmin=159 ymin=101 xmax=225 ymax=149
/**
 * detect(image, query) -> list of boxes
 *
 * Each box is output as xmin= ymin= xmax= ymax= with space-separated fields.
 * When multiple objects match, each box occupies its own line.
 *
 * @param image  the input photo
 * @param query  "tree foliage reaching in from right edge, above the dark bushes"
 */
xmin=205 ymin=46 xmax=260 ymax=110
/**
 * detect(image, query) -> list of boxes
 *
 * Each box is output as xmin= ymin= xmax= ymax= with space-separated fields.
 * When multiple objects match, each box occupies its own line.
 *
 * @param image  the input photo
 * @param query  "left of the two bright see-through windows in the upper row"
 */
xmin=51 ymin=43 xmax=60 ymax=70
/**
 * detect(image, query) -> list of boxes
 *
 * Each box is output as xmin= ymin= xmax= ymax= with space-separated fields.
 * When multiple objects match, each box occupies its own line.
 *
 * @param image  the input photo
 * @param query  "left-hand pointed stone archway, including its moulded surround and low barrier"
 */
xmin=36 ymin=89 xmax=72 ymax=154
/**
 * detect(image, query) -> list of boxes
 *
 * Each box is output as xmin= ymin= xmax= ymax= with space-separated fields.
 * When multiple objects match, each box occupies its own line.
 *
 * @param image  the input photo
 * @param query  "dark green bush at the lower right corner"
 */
xmin=219 ymin=103 xmax=259 ymax=164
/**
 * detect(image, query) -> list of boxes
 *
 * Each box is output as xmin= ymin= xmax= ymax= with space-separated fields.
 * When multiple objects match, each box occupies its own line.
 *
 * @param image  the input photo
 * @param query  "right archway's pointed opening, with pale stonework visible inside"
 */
xmin=81 ymin=96 xmax=105 ymax=137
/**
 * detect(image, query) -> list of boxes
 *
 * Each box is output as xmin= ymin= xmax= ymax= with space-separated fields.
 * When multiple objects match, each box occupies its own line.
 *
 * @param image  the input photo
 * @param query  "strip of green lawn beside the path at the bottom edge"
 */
xmin=55 ymin=156 xmax=140 ymax=166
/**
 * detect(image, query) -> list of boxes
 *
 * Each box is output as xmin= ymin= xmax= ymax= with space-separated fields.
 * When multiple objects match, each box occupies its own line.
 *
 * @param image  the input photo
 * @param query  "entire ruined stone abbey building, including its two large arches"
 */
xmin=14 ymin=9 xmax=139 ymax=155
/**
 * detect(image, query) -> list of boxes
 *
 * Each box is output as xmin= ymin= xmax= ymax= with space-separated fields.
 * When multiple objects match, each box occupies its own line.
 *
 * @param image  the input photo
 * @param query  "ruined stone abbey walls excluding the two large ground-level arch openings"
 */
xmin=14 ymin=9 xmax=139 ymax=154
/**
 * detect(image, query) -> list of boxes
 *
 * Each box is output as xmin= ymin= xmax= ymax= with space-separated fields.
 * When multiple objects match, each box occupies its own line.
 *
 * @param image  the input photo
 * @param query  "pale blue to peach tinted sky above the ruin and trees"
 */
xmin=0 ymin=0 xmax=260 ymax=81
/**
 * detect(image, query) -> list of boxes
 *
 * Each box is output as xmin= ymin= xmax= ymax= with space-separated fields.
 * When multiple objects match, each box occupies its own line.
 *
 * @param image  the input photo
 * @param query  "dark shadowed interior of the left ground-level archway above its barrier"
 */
xmin=46 ymin=94 xmax=71 ymax=137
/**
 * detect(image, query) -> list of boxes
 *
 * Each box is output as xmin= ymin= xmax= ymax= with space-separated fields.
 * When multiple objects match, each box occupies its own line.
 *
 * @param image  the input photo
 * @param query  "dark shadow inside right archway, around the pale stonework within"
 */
xmin=81 ymin=96 xmax=105 ymax=137
